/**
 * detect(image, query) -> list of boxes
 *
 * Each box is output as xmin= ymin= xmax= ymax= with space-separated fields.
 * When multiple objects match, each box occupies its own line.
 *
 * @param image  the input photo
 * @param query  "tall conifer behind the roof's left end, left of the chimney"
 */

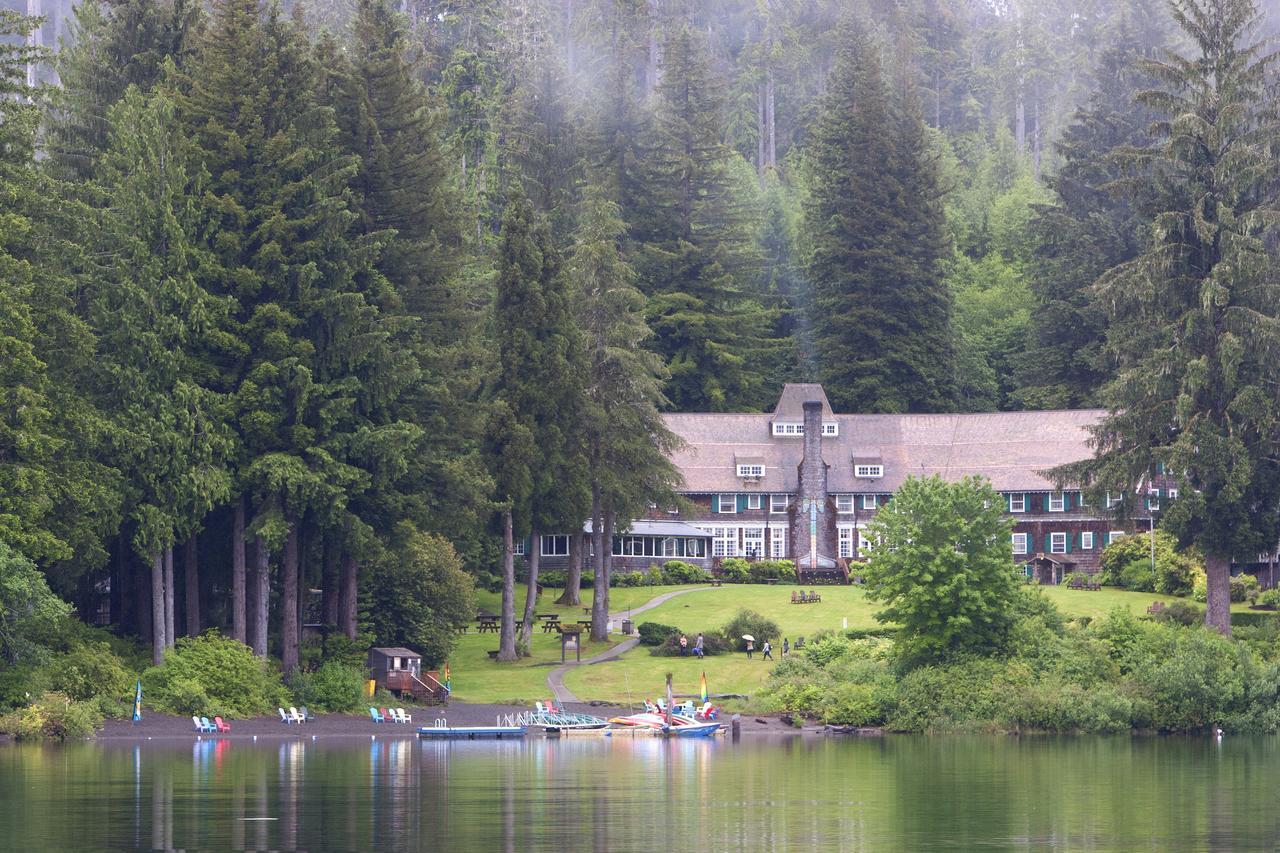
xmin=632 ymin=28 xmax=780 ymax=411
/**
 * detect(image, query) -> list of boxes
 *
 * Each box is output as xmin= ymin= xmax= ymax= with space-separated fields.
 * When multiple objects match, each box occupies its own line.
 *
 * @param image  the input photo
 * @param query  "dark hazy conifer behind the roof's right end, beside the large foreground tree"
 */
xmin=1016 ymin=29 xmax=1156 ymax=409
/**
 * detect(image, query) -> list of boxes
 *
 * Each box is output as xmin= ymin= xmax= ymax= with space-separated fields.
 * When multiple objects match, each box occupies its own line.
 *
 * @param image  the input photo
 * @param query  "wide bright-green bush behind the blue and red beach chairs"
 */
xmin=142 ymin=630 xmax=288 ymax=717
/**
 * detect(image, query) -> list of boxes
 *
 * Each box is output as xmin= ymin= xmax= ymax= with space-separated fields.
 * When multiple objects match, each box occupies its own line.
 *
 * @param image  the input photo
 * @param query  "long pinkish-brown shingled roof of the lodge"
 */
xmin=666 ymin=384 xmax=1105 ymax=494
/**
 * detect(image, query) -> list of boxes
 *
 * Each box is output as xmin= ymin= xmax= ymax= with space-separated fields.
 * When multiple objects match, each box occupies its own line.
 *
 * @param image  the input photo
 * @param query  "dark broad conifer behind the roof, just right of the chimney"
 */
xmin=804 ymin=28 xmax=952 ymax=411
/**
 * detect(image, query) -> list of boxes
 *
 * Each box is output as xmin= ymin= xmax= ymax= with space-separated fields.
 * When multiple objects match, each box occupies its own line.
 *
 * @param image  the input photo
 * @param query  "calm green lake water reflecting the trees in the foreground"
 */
xmin=0 ymin=736 xmax=1280 ymax=853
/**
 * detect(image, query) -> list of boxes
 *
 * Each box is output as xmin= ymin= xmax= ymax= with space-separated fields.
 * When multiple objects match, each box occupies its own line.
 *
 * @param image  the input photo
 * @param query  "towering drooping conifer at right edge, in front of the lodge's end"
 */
xmin=1060 ymin=0 xmax=1280 ymax=634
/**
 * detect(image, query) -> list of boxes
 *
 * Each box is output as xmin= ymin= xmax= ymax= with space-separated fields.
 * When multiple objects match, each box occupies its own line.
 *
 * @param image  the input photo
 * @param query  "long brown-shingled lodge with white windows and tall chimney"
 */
xmin=529 ymin=384 xmax=1176 ymax=583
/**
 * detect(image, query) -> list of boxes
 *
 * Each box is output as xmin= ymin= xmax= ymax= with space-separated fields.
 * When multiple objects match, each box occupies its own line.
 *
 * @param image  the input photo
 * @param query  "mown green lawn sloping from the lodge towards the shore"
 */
xmin=463 ymin=584 xmax=1248 ymax=703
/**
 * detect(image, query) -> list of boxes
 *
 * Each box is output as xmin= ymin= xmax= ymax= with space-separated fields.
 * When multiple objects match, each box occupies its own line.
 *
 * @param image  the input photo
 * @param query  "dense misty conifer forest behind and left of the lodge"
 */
xmin=0 ymin=0 xmax=1280 ymax=672
